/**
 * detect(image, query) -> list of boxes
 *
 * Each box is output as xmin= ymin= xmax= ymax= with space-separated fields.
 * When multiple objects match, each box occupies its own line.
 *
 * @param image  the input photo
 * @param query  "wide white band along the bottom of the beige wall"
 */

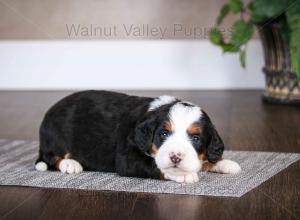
xmin=0 ymin=40 xmax=264 ymax=90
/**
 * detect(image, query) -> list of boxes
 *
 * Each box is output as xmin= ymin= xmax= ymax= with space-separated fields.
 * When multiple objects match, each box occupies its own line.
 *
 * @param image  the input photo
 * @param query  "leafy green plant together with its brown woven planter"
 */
xmin=209 ymin=0 xmax=300 ymax=104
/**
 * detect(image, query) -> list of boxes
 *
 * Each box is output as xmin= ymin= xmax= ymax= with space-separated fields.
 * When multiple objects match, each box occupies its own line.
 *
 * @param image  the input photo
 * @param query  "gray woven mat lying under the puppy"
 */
xmin=0 ymin=139 xmax=300 ymax=197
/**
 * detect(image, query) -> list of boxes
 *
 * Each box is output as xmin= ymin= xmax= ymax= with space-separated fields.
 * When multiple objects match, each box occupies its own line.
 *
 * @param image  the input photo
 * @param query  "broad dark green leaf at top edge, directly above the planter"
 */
xmin=249 ymin=0 xmax=289 ymax=23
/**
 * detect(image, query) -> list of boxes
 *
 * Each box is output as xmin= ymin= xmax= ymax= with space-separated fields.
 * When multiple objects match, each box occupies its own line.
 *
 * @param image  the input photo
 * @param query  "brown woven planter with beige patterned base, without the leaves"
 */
xmin=257 ymin=21 xmax=300 ymax=104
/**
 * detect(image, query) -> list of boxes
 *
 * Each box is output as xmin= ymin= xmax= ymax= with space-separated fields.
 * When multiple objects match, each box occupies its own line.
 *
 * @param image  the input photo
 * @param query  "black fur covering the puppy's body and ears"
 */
xmin=36 ymin=91 xmax=224 ymax=178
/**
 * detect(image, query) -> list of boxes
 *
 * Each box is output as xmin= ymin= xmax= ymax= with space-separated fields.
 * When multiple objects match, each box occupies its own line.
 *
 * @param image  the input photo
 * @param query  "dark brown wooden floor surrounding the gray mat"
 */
xmin=0 ymin=91 xmax=300 ymax=220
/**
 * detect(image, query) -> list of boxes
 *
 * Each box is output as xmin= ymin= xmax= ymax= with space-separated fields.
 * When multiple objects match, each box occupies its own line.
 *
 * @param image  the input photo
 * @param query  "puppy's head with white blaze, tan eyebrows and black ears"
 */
xmin=135 ymin=97 xmax=224 ymax=175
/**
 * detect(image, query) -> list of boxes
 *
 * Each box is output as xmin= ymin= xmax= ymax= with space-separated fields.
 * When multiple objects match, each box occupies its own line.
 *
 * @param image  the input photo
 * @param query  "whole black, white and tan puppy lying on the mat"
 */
xmin=35 ymin=91 xmax=241 ymax=183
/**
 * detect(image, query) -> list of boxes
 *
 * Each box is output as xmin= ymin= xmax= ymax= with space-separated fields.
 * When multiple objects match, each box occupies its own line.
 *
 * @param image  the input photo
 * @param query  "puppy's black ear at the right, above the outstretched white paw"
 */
xmin=205 ymin=124 xmax=224 ymax=163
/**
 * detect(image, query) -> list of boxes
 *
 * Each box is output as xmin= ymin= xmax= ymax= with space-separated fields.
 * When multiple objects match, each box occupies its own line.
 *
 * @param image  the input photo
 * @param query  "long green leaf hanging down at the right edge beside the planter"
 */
xmin=286 ymin=1 xmax=300 ymax=80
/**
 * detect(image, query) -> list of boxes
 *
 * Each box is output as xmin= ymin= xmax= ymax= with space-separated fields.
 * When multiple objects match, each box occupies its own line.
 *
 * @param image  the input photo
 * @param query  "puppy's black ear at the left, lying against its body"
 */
xmin=133 ymin=115 xmax=156 ymax=152
